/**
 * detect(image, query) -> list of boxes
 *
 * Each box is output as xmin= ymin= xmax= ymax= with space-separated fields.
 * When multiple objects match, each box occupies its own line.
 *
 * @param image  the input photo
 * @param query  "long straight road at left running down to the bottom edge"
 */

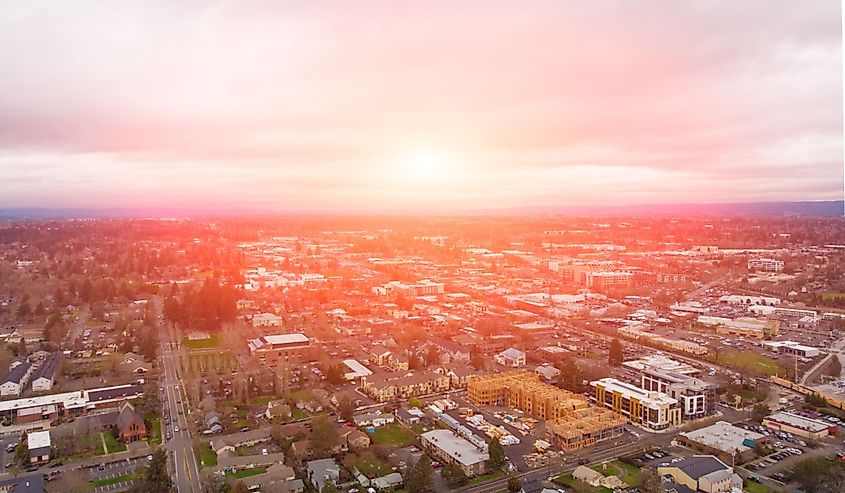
xmin=161 ymin=320 xmax=202 ymax=493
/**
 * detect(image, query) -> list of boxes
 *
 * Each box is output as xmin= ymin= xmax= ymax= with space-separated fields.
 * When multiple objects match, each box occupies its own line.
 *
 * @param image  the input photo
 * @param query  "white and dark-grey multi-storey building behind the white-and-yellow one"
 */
xmin=640 ymin=366 xmax=716 ymax=419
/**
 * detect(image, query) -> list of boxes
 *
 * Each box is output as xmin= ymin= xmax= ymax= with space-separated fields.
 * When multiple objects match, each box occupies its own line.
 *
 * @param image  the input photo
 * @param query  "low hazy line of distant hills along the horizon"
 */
xmin=0 ymin=200 xmax=845 ymax=219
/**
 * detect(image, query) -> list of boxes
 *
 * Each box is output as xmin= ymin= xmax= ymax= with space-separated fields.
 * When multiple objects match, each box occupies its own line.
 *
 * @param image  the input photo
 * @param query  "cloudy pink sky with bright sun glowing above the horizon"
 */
xmin=0 ymin=0 xmax=845 ymax=211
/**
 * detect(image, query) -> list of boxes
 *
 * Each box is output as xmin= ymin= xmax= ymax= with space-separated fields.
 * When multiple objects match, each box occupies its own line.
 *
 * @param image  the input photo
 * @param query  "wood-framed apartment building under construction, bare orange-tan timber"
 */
xmin=467 ymin=370 xmax=627 ymax=451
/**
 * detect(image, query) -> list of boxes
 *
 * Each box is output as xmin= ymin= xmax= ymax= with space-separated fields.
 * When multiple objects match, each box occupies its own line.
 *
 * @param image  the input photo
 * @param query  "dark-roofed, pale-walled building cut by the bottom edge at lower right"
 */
xmin=657 ymin=455 xmax=742 ymax=493
